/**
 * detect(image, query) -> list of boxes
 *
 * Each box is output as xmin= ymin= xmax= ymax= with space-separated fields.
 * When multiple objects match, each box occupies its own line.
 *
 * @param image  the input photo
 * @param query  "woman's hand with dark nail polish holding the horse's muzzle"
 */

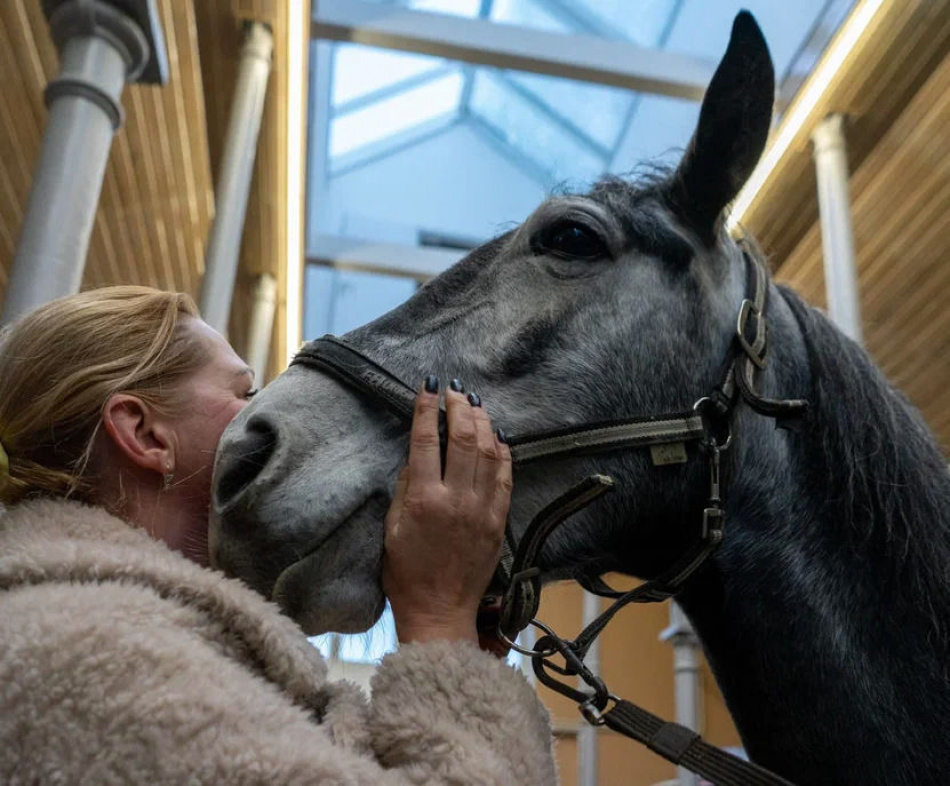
xmin=383 ymin=377 xmax=511 ymax=643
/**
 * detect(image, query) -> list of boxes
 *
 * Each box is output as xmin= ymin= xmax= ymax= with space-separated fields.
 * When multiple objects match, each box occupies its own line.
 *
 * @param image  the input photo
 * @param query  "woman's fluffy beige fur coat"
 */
xmin=0 ymin=501 xmax=556 ymax=786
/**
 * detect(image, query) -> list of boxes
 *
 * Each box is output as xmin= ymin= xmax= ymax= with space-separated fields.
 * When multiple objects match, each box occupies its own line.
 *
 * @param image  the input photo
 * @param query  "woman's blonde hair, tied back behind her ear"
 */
xmin=0 ymin=286 xmax=207 ymax=505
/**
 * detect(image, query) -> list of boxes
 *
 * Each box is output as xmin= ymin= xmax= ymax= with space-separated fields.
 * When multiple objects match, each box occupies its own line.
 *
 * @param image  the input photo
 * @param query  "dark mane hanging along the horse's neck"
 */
xmin=778 ymin=285 xmax=950 ymax=640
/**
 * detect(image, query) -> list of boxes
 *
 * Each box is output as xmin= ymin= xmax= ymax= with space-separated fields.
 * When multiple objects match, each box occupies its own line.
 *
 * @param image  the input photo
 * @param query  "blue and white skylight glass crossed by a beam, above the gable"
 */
xmin=329 ymin=0 xmax=678 ymax=179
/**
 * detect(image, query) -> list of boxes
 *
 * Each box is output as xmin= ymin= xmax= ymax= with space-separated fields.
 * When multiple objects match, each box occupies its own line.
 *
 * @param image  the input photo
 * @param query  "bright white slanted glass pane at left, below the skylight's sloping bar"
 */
xmin=330 ymin=71 xmax=464 ymax=159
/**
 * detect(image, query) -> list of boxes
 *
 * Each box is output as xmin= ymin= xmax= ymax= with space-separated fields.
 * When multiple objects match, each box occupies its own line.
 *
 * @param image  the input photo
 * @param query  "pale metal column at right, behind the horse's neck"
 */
xmin=811 ymin=114 xmax=862 ymax=343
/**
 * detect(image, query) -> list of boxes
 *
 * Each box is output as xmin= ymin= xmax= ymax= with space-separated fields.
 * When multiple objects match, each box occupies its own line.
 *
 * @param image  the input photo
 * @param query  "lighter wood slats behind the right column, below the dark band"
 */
xmin=778 ymin=49 xmax=950 ymax=449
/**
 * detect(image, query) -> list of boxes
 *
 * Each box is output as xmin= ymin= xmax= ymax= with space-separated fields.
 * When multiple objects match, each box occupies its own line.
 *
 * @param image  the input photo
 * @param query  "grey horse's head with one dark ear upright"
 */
xmin=211 ymin=13 xmax=774 ymax=633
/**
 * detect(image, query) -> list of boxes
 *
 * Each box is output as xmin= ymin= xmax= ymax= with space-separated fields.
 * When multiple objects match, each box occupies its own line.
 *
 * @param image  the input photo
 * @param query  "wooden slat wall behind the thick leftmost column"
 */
xmin=0 ymin=0 xmax=214 ymax=294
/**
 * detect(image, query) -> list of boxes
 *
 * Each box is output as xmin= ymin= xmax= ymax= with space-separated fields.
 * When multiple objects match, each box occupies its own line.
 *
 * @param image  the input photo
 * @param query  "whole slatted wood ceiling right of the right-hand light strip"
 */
xmin=745 ymin=0 xmax=950 ymax=452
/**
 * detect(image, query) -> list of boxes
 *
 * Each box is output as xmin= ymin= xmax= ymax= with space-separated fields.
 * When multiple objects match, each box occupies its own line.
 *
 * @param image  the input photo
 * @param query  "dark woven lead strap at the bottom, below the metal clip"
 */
xmin=603 ymin=700 xmax=793 ymax=786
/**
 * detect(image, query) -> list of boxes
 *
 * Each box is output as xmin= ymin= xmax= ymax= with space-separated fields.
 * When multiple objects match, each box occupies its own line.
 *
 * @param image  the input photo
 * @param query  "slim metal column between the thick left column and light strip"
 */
xmin=201 ymin=22 xmax=274 ymax=336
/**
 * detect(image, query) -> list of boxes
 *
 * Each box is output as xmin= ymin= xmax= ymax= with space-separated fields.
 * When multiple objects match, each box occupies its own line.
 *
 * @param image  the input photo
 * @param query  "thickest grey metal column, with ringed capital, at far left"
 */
xmin=3 ymin=0 xmax=149 ymax=322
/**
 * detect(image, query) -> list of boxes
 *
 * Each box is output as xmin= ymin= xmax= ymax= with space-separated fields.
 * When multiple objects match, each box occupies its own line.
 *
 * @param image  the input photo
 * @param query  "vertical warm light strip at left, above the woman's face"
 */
xmin=284 ymin=0 xmax=310 ymax=363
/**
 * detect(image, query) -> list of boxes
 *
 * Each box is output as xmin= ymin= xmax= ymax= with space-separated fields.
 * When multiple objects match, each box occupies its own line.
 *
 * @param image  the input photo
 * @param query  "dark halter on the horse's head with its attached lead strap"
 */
xmin=291 ymin=249 xmax=808 ymax=786
